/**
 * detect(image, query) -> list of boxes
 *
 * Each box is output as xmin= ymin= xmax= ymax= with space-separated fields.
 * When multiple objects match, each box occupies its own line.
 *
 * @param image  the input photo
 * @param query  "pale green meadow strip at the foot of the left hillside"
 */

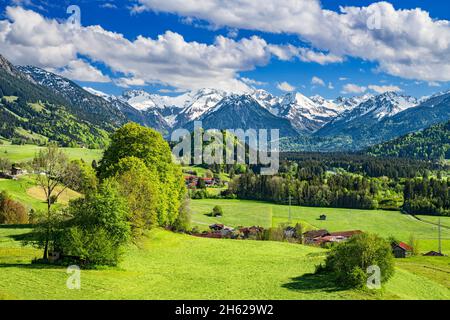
xmin=0 ymin=143 xmax=103 ymax=163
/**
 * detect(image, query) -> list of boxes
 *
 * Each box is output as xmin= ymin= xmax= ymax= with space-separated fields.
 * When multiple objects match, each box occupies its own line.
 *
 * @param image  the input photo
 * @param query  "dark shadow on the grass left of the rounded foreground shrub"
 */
xmin=282 ymin=273 xmax=347 ymax=292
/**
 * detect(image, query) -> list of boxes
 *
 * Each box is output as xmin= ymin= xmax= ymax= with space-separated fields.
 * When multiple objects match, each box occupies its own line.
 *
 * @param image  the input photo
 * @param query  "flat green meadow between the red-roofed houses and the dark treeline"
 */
xmin=191 ymin=199 xmax=450 ymax=254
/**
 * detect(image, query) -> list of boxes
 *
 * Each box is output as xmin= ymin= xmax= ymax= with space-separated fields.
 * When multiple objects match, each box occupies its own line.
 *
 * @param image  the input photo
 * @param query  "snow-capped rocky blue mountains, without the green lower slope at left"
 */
xmin=8 ymin=56 xmax=450 ymax=151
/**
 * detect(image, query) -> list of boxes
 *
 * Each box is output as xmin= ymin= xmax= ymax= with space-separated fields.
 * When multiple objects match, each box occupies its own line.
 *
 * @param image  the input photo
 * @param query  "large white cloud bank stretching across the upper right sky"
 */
xmin=136 ymin=0 xmax=450 ymax=81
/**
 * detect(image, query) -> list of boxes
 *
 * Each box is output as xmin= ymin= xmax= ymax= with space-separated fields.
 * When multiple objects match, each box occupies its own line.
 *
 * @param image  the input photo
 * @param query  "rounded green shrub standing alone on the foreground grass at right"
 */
xmin=325 ymin=233 xmax=394 ymax=288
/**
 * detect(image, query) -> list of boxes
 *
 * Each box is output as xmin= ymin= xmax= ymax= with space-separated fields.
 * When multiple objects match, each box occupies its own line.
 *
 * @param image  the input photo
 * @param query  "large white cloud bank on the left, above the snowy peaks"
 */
xmin=0 ymin=7 xmax=342 ymax=92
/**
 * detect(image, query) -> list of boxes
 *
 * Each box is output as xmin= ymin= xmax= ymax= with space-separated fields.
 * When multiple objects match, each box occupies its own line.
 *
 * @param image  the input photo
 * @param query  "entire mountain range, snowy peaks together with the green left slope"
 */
xmin=0 ymin=56 xmax=450 ymax=151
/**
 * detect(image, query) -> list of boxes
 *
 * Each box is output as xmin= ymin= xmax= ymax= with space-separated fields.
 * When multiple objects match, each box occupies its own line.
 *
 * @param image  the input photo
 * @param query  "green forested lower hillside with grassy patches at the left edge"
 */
xmin=0 ymin=56 xmax=119 ymax=148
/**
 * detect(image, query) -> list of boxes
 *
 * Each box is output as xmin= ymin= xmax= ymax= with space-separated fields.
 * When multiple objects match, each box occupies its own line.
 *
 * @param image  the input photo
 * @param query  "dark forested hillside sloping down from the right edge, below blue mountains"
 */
xmin=368 ymin=122 xmax=450 ymax=160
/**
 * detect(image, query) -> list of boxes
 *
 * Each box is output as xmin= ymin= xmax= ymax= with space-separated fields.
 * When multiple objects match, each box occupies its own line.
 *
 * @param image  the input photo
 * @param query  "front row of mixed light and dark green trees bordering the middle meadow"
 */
xmin=228 ymin=169 xmax=403 ymax=209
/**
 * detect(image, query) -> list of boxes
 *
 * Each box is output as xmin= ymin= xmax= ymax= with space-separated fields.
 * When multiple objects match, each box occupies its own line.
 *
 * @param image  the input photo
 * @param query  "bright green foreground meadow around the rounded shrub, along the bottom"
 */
xmin=0 ymin=227 xmax=450 ymax=300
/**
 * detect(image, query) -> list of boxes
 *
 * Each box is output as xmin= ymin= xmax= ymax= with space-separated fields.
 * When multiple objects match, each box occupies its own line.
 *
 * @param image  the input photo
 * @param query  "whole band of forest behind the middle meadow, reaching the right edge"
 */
xmin=211 ymin=153 xmax=450 ymax=215
